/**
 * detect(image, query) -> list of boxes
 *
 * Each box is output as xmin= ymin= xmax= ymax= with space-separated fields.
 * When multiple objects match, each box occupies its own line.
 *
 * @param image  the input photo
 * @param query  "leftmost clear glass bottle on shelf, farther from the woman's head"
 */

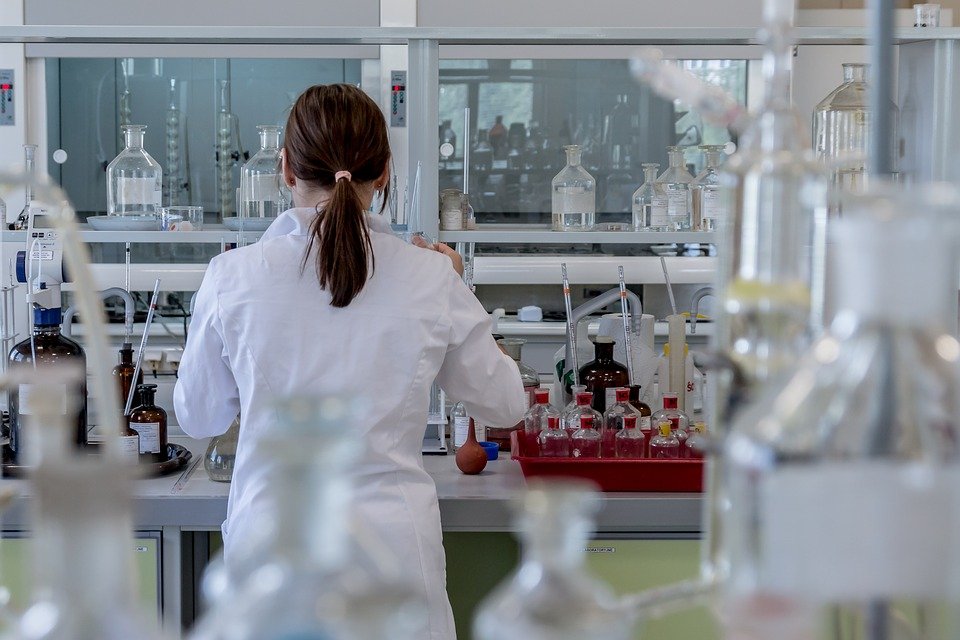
xmin=107 ymin=124 xmax=163 ymax=216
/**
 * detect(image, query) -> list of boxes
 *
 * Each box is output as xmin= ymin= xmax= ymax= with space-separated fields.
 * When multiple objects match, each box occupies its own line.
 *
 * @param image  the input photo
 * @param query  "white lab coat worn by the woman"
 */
xmin=174 ymin=209 xmax=525 ymax=640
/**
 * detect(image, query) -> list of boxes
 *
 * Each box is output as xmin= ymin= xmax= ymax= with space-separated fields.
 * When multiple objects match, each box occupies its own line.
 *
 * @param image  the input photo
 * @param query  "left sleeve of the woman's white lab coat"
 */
xmin=173 ymin=261 xmax=240 ymax=438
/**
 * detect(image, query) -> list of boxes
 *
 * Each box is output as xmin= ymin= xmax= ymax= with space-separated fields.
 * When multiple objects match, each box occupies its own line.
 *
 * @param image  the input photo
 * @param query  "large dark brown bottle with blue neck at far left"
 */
xmin=3 ymin=307 xmax=87 ymax=465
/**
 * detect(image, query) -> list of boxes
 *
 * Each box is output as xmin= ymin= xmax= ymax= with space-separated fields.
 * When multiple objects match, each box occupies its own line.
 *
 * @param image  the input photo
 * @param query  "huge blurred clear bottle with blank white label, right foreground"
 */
xmin=719 ymin=190 xmax=960 ymax=640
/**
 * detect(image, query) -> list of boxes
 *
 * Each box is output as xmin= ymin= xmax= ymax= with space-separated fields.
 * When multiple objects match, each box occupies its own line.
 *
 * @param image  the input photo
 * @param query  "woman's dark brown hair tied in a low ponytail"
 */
xmin=283 ymin=84 xmax=390 ymax=307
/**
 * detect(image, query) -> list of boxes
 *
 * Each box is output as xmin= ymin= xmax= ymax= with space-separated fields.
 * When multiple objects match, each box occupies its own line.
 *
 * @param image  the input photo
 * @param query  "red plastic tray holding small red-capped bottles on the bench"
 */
xmin=510 ymin=431 xmax=703 ymax=493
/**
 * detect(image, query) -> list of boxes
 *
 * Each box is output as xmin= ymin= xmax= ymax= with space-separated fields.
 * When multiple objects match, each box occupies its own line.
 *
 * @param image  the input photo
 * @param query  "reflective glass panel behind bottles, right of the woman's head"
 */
xmin=440 ymin=59 xmax=747 ymax=228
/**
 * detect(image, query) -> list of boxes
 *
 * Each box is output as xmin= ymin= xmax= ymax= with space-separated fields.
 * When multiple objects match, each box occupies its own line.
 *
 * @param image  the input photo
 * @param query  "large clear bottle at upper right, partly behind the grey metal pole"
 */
xmin=813 ymin=62 xmax=899 ymax=198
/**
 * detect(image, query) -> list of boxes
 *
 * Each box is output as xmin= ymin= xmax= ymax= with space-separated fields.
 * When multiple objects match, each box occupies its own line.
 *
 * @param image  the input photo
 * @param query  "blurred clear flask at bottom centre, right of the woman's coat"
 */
xmin=473 ymin=478 xmax=633 ymax=640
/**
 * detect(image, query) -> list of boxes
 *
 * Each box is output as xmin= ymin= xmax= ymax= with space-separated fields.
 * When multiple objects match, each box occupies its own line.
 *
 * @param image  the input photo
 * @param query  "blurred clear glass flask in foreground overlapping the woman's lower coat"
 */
xmin=190 ymin=396 xmax=426 ymax=640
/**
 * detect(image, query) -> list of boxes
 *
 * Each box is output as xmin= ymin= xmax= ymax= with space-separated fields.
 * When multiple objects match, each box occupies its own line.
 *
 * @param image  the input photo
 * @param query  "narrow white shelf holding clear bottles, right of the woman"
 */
xmin=439 ymin=224 xmax=717 ymax=244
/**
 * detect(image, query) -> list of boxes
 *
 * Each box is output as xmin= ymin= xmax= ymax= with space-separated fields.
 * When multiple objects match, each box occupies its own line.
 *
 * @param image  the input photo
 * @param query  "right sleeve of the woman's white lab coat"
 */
xmin=437 ymin=271 xmax=527 ymax=426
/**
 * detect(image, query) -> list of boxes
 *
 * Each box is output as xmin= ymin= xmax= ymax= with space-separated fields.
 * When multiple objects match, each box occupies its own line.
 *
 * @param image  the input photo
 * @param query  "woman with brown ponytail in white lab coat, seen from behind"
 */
xmin=174 ymin=84 xmax=525 ymax=640
